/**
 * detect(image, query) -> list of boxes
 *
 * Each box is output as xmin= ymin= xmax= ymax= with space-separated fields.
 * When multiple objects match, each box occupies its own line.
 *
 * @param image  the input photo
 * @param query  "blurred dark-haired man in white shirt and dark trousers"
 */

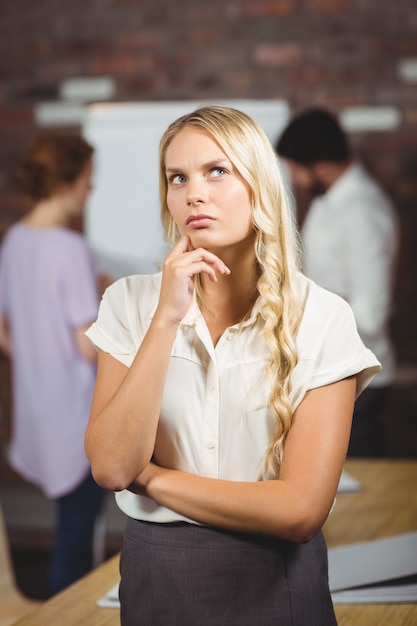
xmin=276 ymin=109 xmax=398 ymax=456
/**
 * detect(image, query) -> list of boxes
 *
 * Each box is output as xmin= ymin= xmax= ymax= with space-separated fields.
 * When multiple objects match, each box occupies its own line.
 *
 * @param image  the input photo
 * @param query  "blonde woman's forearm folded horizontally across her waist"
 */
xmin=135 ymin=464 xmax=334 ymax=542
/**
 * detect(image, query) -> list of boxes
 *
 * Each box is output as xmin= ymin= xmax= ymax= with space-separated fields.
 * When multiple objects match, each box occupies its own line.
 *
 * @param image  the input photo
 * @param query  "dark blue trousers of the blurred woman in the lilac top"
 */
xmin=48 ymin=472 xmax=106 ymax=595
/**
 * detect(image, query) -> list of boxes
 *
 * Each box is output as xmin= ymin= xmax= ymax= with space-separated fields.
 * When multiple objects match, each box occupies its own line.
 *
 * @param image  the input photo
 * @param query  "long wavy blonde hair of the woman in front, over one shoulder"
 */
xmin=159 ymin=106 xmax=304 ymax=476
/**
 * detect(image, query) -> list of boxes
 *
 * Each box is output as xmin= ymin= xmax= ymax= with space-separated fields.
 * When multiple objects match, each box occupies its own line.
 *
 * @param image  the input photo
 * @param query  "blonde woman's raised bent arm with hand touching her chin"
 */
xmin=85 ymin=237 xmax=230 ymax=491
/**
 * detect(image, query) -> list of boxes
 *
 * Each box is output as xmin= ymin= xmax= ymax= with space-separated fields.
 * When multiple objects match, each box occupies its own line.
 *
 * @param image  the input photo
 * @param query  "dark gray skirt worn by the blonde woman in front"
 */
xmin=120 ymin=518 xmax=337 ymax=626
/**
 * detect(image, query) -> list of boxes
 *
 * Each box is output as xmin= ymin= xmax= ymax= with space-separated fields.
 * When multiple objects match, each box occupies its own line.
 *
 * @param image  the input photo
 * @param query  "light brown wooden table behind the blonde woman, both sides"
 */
xmin=15 ymin=459 xmax=417 ymax=626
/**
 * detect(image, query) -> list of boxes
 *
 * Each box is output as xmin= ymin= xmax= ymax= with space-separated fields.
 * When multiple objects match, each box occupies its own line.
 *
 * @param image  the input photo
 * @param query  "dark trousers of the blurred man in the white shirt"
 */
xmin=348 ymin=387 xmax=390 ymax=457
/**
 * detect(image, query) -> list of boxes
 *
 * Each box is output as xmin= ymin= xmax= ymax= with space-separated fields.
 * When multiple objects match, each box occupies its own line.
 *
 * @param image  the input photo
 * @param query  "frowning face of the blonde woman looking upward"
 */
xmin=165 ymin=126 xmax=255 ymax=250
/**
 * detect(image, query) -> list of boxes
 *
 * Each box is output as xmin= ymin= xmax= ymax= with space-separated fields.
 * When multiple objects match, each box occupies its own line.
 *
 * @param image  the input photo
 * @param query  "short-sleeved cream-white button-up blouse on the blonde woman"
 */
xmin=87 ymin=273 xmax=380 ymax=522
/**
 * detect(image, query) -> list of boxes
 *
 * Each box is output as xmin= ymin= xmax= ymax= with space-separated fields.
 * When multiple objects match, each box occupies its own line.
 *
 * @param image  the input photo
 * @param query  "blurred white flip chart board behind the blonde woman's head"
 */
xmin=82 ymin=100 xmax=289 ymax=278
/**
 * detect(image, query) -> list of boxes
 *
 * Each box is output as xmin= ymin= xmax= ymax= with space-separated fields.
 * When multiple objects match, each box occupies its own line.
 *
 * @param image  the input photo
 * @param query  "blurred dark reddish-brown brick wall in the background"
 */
xmin=0 ymin=0 xmax=417 ymax=434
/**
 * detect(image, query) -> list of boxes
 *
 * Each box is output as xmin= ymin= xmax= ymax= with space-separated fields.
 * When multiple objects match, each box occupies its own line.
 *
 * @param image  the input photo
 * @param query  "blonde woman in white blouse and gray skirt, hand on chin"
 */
xmin=86 ymin=106 xmax=380 ymax=626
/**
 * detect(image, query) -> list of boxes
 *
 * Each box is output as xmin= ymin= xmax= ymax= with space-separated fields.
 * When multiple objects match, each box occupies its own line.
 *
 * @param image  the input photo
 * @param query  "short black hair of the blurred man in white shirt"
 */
xmin=276 ymin=108 xmax=350 ymax=165
